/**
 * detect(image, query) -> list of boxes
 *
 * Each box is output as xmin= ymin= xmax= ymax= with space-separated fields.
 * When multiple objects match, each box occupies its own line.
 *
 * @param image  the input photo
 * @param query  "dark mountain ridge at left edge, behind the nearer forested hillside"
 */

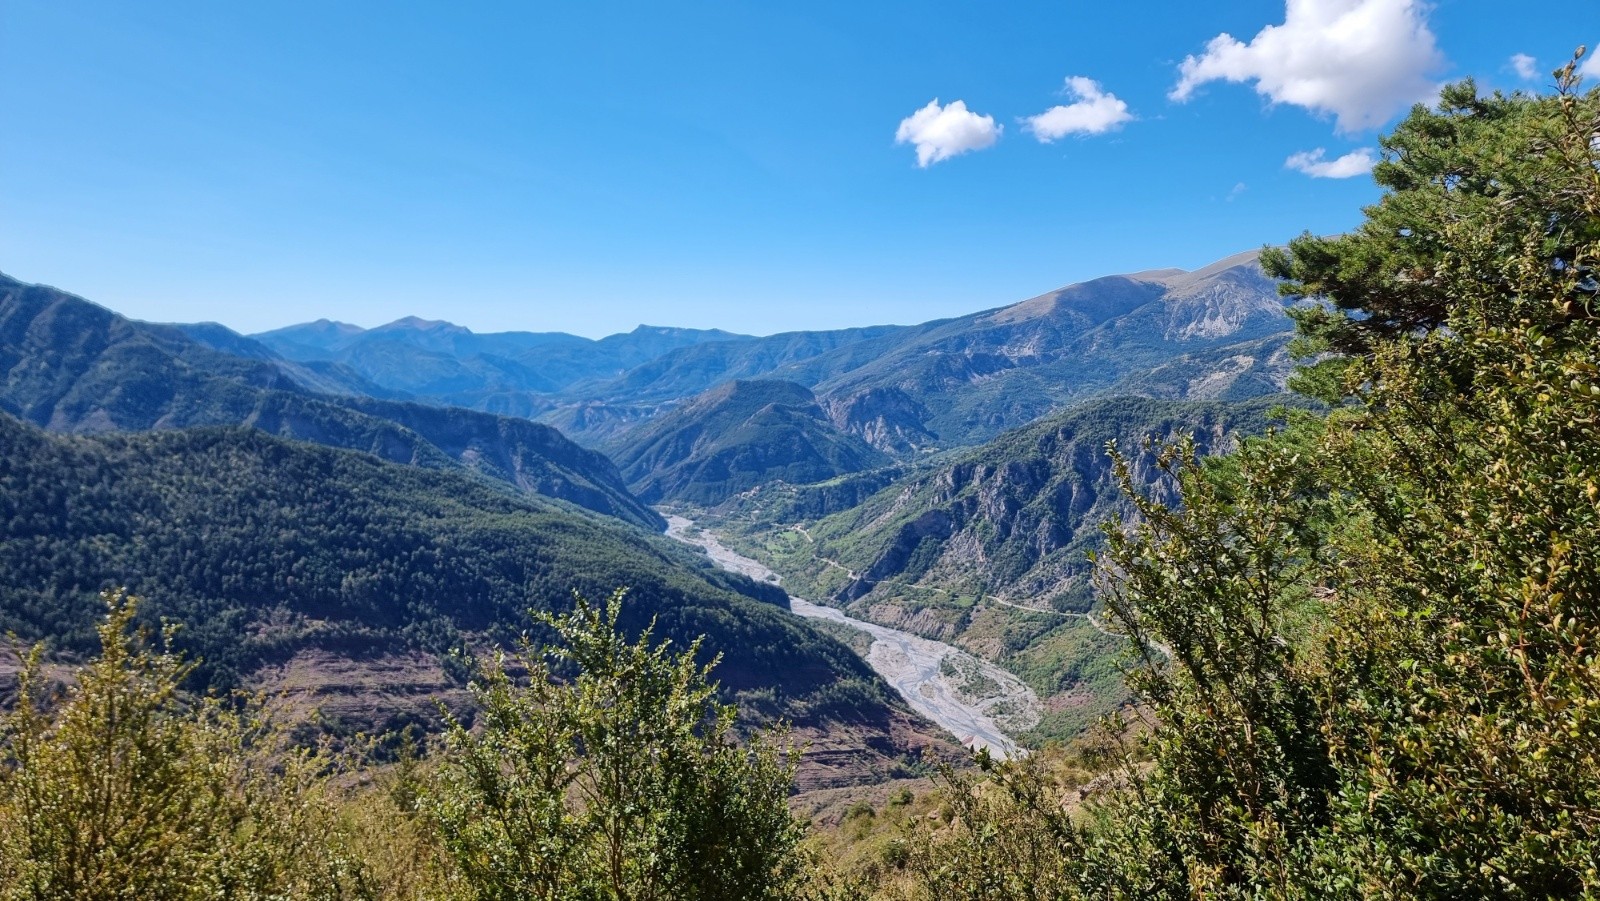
xmin=0 ymin=277 xmax=662 ymax=528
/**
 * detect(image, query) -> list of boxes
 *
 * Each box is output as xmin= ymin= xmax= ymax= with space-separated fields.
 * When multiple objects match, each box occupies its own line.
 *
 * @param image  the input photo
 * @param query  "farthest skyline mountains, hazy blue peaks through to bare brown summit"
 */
xmin=258 ymin=251 xmax=1291 ymax=459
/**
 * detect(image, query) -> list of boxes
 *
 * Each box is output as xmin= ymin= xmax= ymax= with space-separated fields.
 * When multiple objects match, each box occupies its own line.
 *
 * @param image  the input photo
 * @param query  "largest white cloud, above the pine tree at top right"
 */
xmin=1168 ymin=0 xmax=1443 ymax=133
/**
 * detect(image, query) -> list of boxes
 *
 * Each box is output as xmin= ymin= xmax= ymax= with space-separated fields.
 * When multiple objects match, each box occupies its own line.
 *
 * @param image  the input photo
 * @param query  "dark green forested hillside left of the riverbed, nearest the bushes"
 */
xmin=0 ymin=414 xmax=891 ymax=732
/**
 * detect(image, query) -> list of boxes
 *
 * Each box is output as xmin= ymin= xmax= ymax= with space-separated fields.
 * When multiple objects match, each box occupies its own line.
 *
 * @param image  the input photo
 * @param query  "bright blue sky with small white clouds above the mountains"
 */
xmin=0 ymin=0 xmax=1600 ymax=336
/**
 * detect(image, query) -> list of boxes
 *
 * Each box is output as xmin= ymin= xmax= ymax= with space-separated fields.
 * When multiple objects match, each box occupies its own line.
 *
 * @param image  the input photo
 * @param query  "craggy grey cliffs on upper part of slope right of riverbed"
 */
xmin=811 ymin=397 xmax=1292 ymax=611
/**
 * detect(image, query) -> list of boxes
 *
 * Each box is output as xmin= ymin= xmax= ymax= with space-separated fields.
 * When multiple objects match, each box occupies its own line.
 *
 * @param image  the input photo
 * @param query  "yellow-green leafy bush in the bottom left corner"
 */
xmin=0 ymin=594 xmax=362 ymax=901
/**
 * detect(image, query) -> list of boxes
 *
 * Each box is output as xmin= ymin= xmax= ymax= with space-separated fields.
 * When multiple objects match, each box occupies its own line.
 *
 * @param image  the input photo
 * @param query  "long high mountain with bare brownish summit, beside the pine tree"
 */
xmin=569 ymin=253 xmax=1291 ymax=456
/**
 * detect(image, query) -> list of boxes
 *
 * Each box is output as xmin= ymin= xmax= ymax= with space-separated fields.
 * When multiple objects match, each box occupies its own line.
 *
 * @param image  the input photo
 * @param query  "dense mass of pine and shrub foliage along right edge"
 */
xmin=1086 ymin=66 xmax=1600 ymax=898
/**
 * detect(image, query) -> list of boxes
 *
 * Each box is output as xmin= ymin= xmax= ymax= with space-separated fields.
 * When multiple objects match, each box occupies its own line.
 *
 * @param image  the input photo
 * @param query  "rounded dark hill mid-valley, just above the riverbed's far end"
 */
xmin=614 ymin=381 xmax=888 ymax=504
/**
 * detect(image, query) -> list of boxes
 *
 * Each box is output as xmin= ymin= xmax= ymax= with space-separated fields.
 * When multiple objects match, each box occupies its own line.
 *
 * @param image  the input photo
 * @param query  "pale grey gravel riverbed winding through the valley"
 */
xmin=667 ymin=515 xmax=1040 ymax=759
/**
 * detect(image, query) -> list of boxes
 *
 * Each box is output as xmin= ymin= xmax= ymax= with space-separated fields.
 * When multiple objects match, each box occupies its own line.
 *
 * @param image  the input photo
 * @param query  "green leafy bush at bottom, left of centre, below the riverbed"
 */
xmin=422 ymin=592 xmax=802 ymax=901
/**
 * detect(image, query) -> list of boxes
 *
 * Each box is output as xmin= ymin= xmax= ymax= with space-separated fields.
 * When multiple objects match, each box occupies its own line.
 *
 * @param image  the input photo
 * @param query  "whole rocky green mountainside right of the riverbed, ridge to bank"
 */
xmin=707 ymin=395 xmax=1304 ymax=743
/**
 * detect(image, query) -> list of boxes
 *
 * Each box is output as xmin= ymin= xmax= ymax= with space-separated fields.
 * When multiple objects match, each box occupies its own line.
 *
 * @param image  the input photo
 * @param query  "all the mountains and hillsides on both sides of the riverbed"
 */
xmin=0 ymin=253 xmax=1290 ymax=761
